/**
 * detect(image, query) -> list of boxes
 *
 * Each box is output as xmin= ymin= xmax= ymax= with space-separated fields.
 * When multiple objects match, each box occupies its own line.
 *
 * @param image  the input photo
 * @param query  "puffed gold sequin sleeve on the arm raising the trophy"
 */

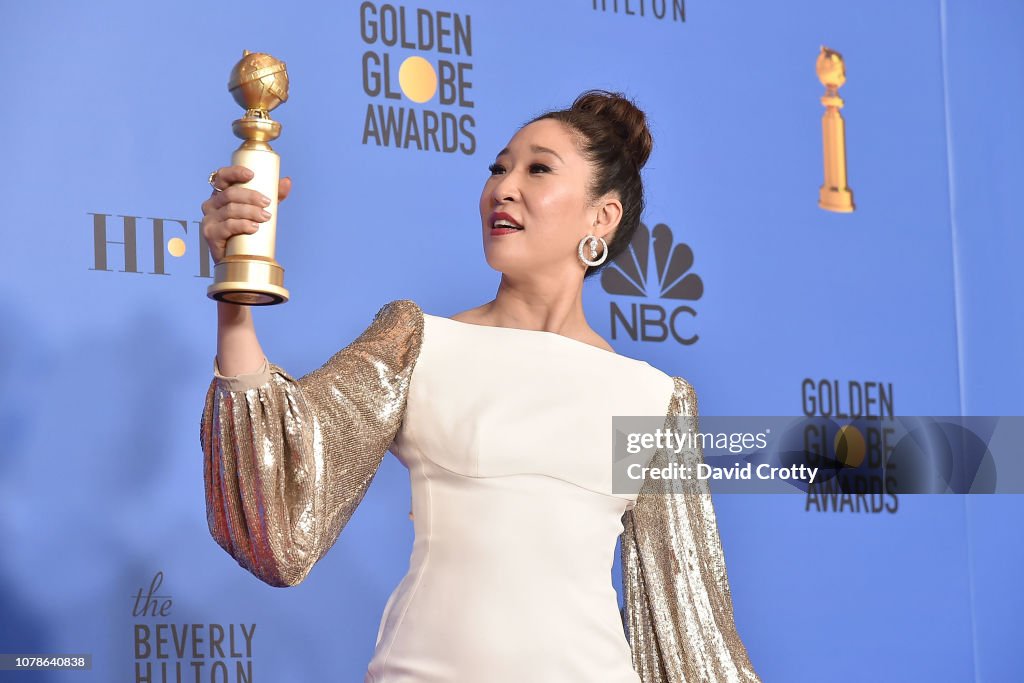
xmin=200 ymin=300 xmax=423 ymax=586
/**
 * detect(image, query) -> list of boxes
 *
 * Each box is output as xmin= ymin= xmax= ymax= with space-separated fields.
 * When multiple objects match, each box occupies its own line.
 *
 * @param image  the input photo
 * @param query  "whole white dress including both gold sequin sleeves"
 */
xmin=200 ymin=300 xmax=760 ymax=683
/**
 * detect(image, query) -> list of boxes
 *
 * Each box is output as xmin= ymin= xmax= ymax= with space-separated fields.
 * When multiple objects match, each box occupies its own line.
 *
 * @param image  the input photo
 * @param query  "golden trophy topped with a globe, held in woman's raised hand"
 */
xmin=206 ymin=50 xmax=288 ymax=306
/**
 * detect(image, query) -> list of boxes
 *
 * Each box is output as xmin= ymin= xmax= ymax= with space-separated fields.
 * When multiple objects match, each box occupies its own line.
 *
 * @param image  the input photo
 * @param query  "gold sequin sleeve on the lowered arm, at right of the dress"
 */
xmin=622 ymin=377 xmax=761 ymax=683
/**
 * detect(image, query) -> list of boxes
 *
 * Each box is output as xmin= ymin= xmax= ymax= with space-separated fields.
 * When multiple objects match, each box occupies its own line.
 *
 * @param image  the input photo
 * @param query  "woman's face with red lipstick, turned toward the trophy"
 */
xmin=480 ymin=119 xmax=599 ymax=275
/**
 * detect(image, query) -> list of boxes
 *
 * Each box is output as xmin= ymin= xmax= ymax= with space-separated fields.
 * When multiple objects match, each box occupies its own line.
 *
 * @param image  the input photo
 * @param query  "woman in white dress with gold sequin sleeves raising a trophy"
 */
xmin=201 ymin=91 xmax=759 ymax=683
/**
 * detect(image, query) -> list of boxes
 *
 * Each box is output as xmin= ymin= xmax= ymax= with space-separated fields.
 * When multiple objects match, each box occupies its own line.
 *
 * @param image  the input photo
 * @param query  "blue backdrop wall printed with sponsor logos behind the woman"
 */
xmin=0 ymin=0 xmax=1024 ymax=682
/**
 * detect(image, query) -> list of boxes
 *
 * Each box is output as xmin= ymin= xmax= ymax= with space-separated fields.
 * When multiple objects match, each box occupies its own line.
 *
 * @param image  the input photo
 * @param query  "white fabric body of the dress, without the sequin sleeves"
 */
xmin=366 ymin=314 xmax=673 ymax=683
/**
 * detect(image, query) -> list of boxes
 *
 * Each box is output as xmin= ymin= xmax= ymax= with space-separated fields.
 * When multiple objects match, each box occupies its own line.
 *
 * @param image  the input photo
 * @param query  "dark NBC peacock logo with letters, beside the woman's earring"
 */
xmin=601 ymin=222 xmax=703 ymax=346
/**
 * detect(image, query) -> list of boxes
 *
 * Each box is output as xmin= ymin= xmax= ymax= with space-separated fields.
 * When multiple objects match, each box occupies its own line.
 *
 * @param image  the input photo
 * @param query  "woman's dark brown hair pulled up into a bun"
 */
xmin=527 ymin=90 xmax=654 ymax=278
